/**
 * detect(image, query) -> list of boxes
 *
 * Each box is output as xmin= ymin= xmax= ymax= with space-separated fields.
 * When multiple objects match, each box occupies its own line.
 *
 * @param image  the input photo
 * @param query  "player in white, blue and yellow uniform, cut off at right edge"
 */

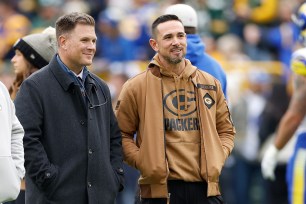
xmin=261 ymin=3 xmax=306 ymax=204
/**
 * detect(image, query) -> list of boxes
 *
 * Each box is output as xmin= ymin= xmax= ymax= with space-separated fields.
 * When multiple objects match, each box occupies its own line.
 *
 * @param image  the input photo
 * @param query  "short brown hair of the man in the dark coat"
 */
xmin=55 ymin=12 xmax=95 ymax=39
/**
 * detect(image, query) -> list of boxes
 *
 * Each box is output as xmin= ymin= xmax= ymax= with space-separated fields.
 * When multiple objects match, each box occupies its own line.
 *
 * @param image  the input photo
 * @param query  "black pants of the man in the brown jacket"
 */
xmin=140 ymin=180 xmax=224 ymax=204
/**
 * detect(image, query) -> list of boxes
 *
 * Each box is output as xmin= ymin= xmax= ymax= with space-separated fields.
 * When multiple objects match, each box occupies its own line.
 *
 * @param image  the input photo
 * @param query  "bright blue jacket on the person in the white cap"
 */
xmin=186 ymin=34 xmax=227 ymax=98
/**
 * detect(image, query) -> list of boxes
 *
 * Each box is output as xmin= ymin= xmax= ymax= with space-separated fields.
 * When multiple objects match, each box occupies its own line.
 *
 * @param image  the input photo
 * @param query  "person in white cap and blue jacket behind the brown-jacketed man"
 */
xmin=165 ymin=4 xmax=227 ymax=97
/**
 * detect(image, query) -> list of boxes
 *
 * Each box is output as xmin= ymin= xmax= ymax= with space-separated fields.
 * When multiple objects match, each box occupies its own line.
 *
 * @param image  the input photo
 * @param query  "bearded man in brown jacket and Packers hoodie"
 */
xmin=115 ymin=15 xmax=235 ymax=204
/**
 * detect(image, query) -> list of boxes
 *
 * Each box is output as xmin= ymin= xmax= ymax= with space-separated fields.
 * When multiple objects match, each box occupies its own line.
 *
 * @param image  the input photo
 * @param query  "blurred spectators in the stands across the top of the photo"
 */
xmin=0 ymin=0 xmax=303 ymax=78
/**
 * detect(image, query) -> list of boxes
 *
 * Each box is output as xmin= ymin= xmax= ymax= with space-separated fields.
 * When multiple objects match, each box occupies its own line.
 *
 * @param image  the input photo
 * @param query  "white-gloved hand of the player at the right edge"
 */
xmin=261 ymin=145 xmax=279 ymax=180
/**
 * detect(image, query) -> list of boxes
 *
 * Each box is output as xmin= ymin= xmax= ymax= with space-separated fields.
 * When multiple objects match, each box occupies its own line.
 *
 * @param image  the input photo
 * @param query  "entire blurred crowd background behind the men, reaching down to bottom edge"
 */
xmin=0 ymin=0 xmax=304 ymax=204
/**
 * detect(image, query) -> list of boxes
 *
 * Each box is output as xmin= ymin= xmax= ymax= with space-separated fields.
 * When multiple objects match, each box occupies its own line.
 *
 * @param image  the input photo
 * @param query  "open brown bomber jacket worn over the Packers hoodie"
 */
xmin=115 ymin=56 xmax=235 ymax=198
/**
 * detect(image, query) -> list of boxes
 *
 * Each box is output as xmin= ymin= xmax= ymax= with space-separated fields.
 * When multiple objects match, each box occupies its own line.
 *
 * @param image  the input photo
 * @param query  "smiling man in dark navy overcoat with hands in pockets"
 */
xmin=15 ymin=13 xmax=123 ymax=204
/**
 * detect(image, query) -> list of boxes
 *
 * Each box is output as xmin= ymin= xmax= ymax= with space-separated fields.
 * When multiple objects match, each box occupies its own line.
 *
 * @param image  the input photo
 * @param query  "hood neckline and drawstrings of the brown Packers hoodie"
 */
xmin=149 ymin=54 xmax=197 ymax=119
